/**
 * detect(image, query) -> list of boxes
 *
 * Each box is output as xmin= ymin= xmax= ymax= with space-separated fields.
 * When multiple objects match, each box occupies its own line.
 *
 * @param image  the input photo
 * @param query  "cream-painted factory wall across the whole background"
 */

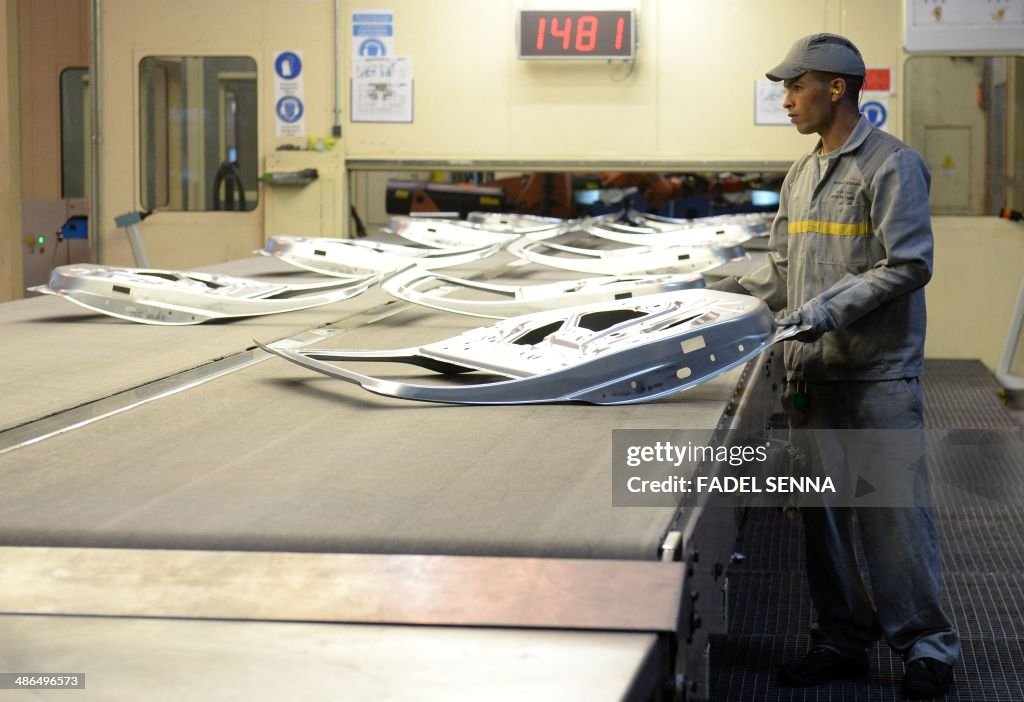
xmin=0 ymin=0 xmax=1024 ymax=374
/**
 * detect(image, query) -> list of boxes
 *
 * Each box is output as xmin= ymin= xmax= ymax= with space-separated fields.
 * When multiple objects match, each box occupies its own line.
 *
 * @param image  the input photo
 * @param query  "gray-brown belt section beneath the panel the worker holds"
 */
xmin=0 ymin=282 xmax=739 ymax=560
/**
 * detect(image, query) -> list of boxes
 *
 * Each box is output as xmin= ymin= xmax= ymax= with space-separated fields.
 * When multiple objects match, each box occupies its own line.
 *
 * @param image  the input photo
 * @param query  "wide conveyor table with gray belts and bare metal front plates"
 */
xmin=0 ymin=248 xmax=770 ymax=701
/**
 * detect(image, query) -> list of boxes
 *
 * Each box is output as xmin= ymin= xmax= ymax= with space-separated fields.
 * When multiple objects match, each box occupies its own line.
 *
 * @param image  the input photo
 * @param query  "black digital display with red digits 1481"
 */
xmin=519 ymin=10 xmax=636 ymax=58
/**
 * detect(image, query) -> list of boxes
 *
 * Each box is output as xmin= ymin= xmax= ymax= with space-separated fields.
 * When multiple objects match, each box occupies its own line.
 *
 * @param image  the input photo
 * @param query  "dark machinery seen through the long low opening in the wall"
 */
xmin=386 ymin=172 xmax=782 ymax=219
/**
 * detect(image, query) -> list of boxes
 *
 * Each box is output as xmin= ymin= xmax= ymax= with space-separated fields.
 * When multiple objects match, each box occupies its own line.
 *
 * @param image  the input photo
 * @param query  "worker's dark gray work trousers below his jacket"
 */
xmin=783 ymin=379 xmax=959 ymax=664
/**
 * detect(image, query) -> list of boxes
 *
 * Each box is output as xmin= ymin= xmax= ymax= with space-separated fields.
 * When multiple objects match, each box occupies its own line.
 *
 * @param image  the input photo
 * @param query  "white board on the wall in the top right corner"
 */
xmin=903 ymin=0 xmax=1024 ymax=51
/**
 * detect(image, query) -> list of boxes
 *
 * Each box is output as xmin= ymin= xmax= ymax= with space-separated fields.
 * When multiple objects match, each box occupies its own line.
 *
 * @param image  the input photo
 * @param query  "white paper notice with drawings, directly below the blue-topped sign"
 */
xmin=350 ymin=56 xmax=413 ymax=123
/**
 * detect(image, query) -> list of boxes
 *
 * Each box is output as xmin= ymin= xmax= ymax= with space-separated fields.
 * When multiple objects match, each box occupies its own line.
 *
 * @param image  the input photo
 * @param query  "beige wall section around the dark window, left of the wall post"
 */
xmin=101 ymin=0 xmax=334 ymax=268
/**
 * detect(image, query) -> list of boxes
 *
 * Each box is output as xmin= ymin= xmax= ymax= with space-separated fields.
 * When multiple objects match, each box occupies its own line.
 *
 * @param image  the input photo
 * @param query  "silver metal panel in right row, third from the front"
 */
xmin=508 ymin=238 xmax=746 ymax=275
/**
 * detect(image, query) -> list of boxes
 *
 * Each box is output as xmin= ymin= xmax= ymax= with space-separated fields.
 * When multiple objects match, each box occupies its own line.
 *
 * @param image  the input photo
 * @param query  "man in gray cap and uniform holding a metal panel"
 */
xmin=711 ymin=34 xmax=959 ymax=699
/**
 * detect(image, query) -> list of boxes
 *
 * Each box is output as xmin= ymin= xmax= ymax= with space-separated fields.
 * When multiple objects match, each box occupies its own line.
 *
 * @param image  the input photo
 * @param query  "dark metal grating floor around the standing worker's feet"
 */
xmin=712 ymin=360 xmax=1024 ymax=702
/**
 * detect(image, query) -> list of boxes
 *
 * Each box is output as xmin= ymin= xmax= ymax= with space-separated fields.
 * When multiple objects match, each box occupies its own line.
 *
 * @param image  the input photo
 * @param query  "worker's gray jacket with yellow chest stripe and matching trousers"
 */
xmin=738 ymin=117 xmax=959 ymax=664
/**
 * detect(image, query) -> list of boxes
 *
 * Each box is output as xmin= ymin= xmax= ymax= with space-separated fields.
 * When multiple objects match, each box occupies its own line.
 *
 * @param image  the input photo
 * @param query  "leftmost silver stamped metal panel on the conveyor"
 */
xmin=29 ymin=263 xmax=378 ymax=325
